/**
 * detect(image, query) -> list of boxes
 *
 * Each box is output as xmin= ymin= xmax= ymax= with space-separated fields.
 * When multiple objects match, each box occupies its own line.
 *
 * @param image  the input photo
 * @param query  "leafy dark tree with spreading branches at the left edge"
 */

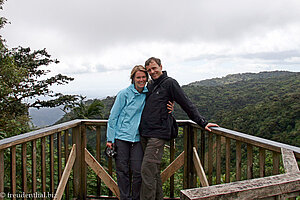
xmin=0 ymin=0 xmax=79 ymax=137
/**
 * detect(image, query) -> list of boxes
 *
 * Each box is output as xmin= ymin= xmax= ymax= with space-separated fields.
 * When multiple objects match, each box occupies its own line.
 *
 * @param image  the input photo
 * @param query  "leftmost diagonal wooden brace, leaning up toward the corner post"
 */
xmin=54 ymin=144 xmax=76 ymax=200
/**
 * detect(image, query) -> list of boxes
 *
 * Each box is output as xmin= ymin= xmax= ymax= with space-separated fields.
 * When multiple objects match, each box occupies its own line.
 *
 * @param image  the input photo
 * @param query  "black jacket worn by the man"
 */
xmin=139 ymin=71 xmax=207 ymax=140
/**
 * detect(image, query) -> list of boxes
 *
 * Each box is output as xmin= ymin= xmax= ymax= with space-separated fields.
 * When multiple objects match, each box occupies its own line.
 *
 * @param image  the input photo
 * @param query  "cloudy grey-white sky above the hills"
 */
xmin=1 ymin=0 xmax=300 ymax=98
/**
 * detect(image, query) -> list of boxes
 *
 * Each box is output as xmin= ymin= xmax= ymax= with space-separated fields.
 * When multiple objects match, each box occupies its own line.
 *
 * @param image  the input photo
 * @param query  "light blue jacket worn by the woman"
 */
xmin=107 ymin=84 xmax=148 ymax=143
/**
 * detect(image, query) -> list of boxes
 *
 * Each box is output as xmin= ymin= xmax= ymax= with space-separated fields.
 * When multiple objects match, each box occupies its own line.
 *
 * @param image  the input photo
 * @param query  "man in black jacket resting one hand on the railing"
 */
xmin=140 ymin=57 xmax=218 ymax=200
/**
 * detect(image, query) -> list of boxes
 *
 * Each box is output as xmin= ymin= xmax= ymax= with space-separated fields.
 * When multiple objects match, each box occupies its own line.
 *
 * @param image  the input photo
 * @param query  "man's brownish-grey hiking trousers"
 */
xmin=141 ymin=137 xmax=166 ymax=200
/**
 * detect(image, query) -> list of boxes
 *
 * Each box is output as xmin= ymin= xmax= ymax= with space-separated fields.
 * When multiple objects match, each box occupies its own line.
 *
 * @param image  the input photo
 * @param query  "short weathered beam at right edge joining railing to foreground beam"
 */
xmin=281 ymin=148 xmax=299 ymax=173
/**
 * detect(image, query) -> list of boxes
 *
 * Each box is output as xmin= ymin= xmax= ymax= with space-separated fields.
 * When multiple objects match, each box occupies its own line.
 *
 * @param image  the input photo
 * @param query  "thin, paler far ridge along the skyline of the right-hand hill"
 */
xmin=187 ymin=71 xmax=294 ymax=86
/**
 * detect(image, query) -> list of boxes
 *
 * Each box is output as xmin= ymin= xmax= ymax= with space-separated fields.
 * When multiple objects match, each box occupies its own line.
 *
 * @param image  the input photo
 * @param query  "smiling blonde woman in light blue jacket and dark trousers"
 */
xmin=106 ymin=65 xmax=173 ymax=200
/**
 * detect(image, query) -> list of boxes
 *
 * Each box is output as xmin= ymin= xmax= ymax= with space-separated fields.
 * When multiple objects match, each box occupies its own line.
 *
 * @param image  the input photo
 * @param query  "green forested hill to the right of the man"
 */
xmin=174 ymin=71 xmax=300 ymax=146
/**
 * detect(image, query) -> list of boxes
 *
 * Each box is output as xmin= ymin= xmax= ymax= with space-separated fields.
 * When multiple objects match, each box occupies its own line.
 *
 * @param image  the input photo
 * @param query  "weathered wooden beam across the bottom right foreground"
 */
xmin=180 ymin=172 xmax=300 ymax=200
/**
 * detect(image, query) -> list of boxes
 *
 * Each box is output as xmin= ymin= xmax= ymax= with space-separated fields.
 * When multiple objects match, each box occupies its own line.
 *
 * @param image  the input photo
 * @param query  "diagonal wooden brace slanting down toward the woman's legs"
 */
xmin=85 ymin=149 xmax=120 ymax=198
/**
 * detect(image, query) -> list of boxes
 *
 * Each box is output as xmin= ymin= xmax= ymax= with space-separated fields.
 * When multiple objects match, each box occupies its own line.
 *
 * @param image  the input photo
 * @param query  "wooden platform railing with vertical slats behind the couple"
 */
xmin=0 ymin=120 xmax=300 ymax=199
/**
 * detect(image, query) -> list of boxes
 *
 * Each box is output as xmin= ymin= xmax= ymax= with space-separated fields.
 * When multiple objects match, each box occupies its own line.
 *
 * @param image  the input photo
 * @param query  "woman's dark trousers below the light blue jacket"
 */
xmin=116 ymin=140 xmax=143 ymax=200
